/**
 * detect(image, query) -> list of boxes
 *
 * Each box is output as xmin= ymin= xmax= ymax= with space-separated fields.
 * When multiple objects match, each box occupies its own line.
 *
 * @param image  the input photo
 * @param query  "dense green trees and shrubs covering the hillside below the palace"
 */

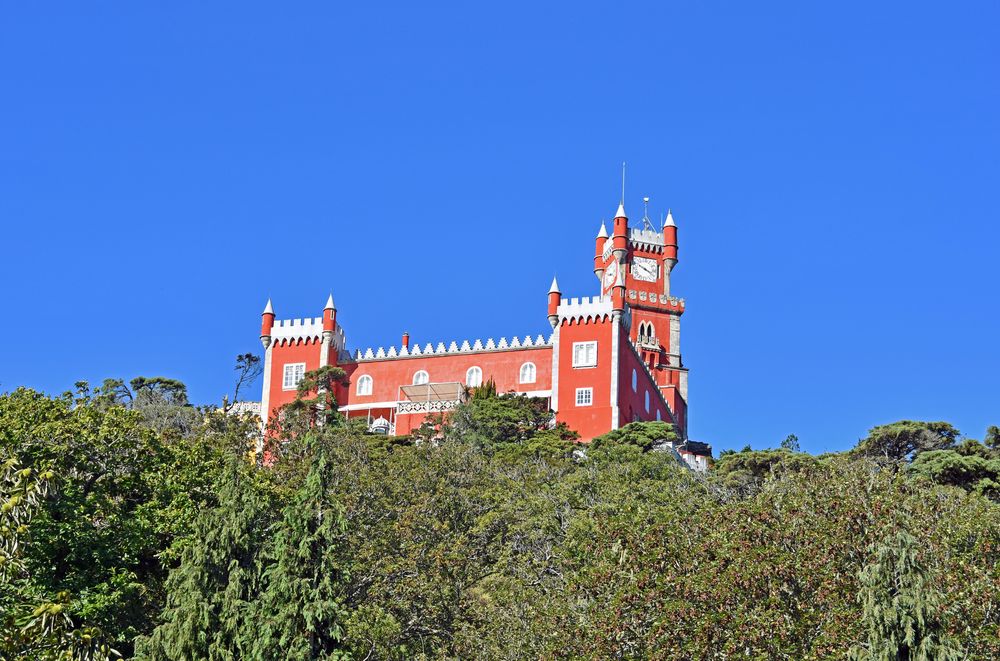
xmin=0 ymin=369 xmax=1000 ymax=659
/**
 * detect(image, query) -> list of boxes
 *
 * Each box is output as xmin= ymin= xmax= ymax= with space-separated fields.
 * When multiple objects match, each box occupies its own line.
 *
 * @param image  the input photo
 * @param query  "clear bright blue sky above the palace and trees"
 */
xmin=0 ymin=2 xmax=1000 ymax=452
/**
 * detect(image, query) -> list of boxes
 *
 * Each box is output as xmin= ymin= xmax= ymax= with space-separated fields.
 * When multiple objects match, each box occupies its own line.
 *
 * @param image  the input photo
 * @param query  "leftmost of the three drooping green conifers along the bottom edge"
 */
xmin=136 ymin=457 xmax=274 ymax=661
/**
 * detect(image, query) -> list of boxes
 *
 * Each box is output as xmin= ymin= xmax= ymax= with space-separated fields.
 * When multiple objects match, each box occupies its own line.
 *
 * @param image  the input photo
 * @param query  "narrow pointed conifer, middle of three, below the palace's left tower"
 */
xmin=253 ymin=433 xmax=346 ymax=660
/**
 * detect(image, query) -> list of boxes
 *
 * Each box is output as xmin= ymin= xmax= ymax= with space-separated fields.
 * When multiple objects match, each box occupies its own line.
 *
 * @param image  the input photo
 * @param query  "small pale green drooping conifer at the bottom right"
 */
xmin=851 ymin=531 xmax=962 ymax=661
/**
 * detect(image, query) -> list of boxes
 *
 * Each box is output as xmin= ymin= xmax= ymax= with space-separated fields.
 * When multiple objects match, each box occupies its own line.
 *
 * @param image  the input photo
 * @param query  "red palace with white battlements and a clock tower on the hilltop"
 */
xmin=260 ymin=198 xmax=711 ymax=469
